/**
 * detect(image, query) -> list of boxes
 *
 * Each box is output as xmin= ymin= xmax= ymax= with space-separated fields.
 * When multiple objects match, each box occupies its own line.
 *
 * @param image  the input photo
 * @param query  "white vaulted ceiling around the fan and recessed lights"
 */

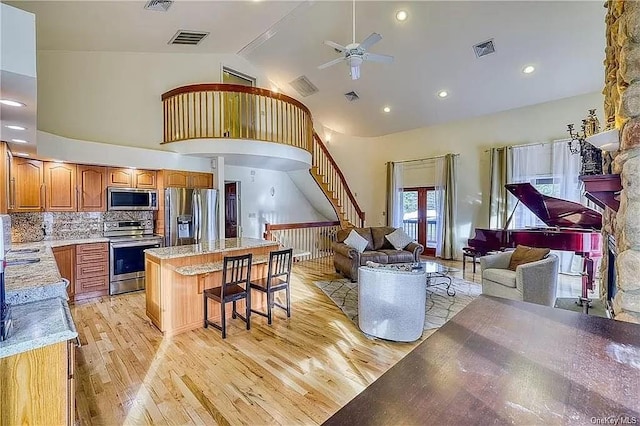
xmin=9 ymin=0 xmax=606 ymax=136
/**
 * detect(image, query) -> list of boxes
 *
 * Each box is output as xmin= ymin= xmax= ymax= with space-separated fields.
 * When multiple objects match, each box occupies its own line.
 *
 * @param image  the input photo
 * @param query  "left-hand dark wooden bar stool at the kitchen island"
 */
xmin=202 ymin=253 xmax=252 ymax=339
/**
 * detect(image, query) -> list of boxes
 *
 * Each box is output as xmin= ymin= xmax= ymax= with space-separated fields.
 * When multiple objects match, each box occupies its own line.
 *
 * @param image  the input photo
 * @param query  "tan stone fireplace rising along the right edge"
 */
xmin=600 ymin=0 xmax=640 ymax=323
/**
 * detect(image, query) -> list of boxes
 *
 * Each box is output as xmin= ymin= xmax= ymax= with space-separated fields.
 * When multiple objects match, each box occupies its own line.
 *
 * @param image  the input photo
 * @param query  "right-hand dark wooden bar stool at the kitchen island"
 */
xmin=251 ymin=248 xmax=293 ymax=325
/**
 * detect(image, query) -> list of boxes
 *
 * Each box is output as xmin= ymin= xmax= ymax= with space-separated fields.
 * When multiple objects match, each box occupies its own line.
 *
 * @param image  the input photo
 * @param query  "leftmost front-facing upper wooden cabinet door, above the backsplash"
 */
xmin=8 ymin=157 xmax=44 ymax=213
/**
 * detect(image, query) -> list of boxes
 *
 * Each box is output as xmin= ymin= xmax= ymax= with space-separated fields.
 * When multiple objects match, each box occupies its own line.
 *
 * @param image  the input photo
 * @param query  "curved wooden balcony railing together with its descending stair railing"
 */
xmin=162 ymin=83 xmax=364 ymax=230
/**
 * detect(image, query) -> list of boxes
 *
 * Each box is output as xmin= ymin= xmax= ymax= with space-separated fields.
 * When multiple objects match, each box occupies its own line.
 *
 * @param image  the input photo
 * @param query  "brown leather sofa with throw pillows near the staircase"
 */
xmin=331 ymin=226 xmax=424 ymax=282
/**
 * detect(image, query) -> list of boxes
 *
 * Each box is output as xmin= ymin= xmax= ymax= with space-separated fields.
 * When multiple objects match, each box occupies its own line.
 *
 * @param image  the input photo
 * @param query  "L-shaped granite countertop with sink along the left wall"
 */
xmin=5 ymin=238 xmax=109 ymax=305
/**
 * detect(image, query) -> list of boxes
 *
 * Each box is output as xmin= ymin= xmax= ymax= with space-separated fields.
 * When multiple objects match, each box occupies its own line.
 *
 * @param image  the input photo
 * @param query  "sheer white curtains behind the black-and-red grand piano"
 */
xmin=511 ymin=140 xmax=581 ymax=273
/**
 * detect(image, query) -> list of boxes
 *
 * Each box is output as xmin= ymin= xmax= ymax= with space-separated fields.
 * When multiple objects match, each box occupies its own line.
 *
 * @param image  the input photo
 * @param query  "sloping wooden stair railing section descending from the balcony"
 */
xmin=309 ymin=131 xmax=364 ymax=228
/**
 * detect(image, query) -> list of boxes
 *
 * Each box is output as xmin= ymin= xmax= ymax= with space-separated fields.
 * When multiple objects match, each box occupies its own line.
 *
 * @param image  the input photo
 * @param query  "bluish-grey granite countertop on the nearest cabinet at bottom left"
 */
xmin=0 ymin=297 xmax=78 ymax=358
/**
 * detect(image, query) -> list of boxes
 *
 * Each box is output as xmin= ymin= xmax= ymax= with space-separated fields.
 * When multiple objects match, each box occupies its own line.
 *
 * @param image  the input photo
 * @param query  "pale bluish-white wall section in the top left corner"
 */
xmin=0 ymin=3 xmax=36 ymax=77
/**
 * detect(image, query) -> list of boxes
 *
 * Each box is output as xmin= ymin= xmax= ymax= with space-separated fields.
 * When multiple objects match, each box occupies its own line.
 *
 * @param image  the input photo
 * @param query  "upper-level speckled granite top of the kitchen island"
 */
xmin=145 ymin=238 xmax=278 ymax=259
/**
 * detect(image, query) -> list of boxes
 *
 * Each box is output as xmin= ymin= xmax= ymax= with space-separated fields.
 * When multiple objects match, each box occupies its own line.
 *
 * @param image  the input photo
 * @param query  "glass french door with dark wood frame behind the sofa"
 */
xmin=402 ymin=186 xmax=438 ymax=256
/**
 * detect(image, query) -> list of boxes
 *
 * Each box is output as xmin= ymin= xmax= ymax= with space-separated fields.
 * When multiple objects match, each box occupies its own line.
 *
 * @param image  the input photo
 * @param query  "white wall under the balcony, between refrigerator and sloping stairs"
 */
xmin=224 ymin=165 xmax=328 ymax=238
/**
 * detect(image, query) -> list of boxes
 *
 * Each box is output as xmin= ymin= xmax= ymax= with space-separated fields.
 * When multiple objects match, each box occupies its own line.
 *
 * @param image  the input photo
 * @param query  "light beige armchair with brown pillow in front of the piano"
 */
xmin=480 ymin=251 xmax=558 ymax=306
